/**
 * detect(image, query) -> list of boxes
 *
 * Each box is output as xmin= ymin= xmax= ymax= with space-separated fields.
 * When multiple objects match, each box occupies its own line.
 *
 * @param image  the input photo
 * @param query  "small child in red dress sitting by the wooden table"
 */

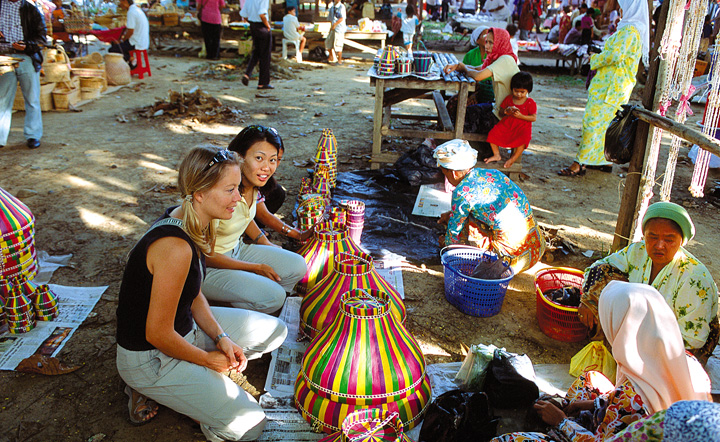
xmin=485 ymin=72 xmax=537 ymax=169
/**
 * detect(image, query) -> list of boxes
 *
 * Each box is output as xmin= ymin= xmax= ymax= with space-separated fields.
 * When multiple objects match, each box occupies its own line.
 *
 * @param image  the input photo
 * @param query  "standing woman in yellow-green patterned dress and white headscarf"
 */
xmin=558 ymin=0 xmax=650 ymax=177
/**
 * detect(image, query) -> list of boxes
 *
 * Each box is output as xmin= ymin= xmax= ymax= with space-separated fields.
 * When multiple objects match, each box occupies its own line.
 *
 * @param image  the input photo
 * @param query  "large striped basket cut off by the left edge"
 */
xmin=0 ymin=187 xmax=38 ymax=293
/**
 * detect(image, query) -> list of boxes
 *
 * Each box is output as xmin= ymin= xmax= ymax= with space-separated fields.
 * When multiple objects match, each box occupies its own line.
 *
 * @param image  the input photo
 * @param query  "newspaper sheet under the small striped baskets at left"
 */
xmin=0 ymin=284 xmax=108 ymax=370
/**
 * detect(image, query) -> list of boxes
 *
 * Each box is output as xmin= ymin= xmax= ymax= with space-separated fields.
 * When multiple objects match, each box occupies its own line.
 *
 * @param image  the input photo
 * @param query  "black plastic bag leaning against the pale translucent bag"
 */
xmin=483 ymin=350 xmax=540 ymax=408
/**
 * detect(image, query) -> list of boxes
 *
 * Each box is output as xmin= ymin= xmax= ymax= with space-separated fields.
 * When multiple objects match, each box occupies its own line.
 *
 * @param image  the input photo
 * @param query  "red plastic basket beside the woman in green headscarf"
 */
xmin=535 ymin=267 xmax=588 ymax=342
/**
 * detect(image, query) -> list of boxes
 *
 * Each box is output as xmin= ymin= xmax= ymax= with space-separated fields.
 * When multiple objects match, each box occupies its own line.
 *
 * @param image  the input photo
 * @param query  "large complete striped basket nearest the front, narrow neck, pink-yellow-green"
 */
xmin=295 ymin=289 xmax=432 ymax=433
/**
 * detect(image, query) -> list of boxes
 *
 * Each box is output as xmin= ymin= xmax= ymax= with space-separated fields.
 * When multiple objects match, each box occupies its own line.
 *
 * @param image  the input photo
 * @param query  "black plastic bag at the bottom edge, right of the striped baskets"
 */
xmin=418 ymin=390 xmax=500 ymax=442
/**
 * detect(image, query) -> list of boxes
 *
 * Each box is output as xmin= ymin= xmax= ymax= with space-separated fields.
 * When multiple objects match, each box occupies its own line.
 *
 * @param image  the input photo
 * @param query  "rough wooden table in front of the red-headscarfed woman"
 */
xmin=370 ymin=76 xmax=487 ymax=169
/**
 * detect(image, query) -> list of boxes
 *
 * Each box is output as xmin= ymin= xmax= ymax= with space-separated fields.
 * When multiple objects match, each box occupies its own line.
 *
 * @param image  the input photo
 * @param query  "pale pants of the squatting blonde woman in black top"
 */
xmin=117 ymin=307 xmax=287 ymax=442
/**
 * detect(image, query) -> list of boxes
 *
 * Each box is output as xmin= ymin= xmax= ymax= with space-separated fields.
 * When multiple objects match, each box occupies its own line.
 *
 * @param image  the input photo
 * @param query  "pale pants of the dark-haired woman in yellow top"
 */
xmin=202 ymin=241 xmax=307 ymax=313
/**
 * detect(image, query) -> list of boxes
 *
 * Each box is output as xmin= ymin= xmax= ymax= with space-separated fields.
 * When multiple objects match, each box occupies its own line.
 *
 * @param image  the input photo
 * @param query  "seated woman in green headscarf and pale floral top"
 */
xmin=578 ymin=202 xmax=720 ymax=359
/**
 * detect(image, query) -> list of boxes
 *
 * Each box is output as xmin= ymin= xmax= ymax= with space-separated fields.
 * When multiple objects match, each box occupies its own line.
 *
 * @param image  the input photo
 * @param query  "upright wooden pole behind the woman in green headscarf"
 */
xmin=611 ymin=1 xmax=670 ymax=252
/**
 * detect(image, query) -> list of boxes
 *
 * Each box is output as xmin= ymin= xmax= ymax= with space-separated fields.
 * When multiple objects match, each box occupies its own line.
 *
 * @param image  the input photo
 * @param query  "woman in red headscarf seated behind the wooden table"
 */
xmin=445 ymin=28 xmax=520 ymax=134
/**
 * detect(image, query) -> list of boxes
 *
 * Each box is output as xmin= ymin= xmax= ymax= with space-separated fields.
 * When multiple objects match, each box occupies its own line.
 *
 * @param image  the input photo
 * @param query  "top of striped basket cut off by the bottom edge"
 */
xmin=320 ymin=408 xmax=412 ymax=442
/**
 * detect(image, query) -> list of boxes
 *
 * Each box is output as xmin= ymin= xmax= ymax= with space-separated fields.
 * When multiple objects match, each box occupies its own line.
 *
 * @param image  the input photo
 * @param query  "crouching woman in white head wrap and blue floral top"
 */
xmin=433 ymin=140 xmax=545 ymax=274
